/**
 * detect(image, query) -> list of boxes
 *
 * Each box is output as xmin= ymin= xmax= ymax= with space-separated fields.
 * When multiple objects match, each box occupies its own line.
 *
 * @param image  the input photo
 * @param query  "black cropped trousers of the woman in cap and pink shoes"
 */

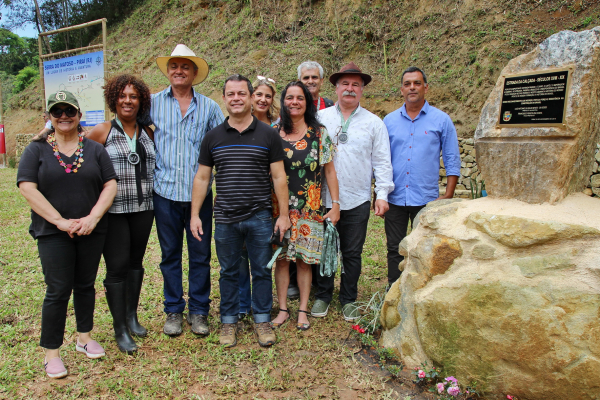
xmin=38 ymin=232 xmax=105 ymax=350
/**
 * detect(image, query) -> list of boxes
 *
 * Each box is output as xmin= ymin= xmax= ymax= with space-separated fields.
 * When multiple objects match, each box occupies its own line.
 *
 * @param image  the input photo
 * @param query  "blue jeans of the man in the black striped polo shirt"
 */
xmin=215 ymin=210 xmax=273 ymax=324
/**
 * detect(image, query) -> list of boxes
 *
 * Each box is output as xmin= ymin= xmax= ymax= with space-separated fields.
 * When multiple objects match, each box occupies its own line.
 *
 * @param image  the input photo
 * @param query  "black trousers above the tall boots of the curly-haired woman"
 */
xmin=103 ymin=210 xmax=154 ymax=283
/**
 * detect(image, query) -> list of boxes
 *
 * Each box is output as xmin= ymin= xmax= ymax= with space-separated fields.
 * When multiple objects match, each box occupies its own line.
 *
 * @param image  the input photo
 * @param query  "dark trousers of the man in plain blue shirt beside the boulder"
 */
xmin=385 ymin=203 xmax=425 ymax=284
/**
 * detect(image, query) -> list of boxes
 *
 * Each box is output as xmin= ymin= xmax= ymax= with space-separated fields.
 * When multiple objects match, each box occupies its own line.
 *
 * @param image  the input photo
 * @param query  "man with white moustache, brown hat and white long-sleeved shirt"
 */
xmin=311 ymin=62 xmax=394 ymax=321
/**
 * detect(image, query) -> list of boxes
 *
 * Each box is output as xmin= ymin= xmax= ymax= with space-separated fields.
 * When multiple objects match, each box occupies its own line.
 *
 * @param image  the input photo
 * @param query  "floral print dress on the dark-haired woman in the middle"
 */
xmin=272 ymin=126 xmax=334 ymax=264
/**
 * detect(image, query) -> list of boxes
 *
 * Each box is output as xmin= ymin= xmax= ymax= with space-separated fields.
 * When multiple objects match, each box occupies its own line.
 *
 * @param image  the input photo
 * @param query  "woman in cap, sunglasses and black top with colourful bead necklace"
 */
xmin=17 ymin=91 xmax=117 ymax=378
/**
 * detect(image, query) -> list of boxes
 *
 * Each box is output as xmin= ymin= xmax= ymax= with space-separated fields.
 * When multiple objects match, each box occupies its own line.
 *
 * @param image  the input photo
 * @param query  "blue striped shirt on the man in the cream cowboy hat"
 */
xmin=150 ymin=86 xmax=225 ymax=202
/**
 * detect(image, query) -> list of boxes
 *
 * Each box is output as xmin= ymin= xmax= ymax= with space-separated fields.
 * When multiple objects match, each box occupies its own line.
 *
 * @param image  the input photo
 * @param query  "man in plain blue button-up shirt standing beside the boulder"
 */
xmin=383 ymin=67 xmax=460 ymax=285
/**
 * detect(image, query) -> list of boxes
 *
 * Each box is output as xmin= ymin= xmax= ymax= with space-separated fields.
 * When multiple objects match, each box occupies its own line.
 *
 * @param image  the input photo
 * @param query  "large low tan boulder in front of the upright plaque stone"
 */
xmin=381 ymin=197 xmax=600 ymax=400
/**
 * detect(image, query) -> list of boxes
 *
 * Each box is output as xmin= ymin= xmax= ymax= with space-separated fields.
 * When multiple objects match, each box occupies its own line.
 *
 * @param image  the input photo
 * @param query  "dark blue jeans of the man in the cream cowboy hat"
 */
xmin=154 ymin=192 xmax=212 ymax=315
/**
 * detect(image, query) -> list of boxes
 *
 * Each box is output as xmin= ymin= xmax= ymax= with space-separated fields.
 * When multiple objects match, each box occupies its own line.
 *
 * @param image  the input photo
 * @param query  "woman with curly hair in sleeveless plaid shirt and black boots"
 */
xmin=87 ymin=75 xmax=156 ymax=354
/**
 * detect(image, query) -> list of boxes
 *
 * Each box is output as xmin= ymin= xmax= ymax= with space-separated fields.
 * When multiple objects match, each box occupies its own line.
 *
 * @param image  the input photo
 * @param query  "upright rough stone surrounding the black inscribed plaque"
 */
xmin=475 ymin=27 xmax=600 ymax=203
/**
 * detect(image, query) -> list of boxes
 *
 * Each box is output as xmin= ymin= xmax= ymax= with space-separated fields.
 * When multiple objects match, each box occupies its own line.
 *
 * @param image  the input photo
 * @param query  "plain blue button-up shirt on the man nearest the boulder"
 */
xmin=383 ymin=101 xmax=460 ymax=206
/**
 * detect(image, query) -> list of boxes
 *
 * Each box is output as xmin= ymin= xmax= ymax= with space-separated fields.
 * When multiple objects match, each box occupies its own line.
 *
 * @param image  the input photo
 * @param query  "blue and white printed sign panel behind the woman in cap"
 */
xmin=44 ymin=51 xmax=105 ymax=126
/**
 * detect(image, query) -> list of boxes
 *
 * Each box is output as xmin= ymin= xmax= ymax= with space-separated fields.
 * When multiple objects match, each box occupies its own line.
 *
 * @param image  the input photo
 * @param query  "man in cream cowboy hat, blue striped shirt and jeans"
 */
xmin=150 ymin=44 xmax=224 ymax=336
